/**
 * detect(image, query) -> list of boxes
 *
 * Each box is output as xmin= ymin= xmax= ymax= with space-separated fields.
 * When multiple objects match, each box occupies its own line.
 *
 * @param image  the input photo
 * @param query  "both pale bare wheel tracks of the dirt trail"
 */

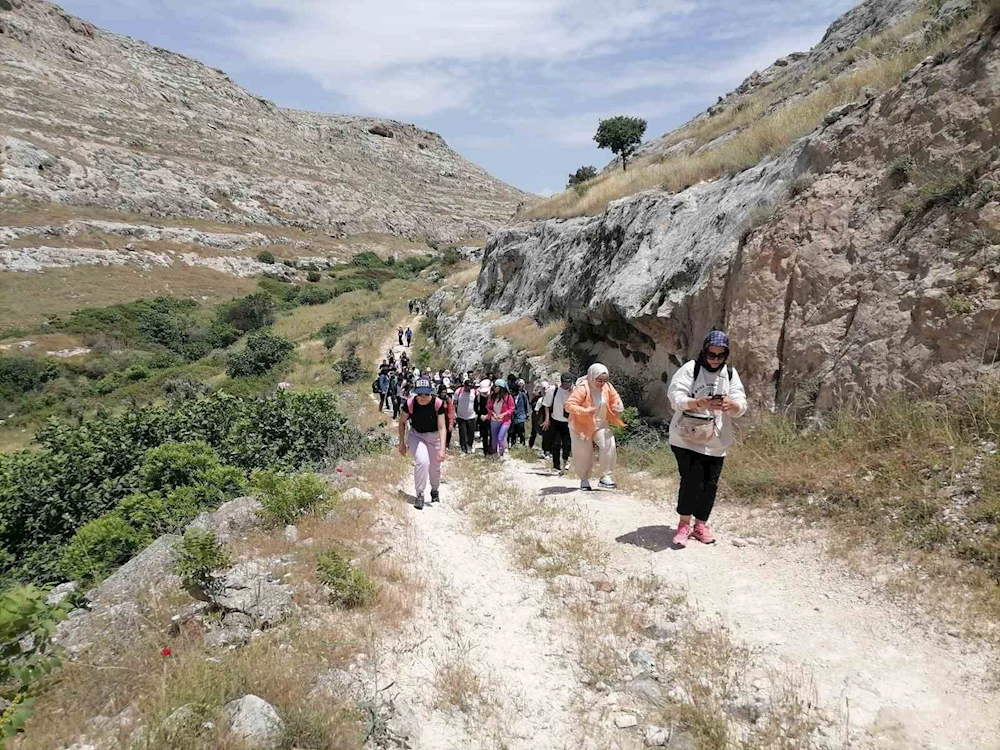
xmin=374 ymin=318 xmax=1000 ymax=750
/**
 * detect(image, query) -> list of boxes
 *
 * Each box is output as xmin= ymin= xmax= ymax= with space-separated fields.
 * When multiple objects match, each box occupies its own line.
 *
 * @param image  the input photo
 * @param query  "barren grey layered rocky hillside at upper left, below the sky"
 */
xmin=0 ymin=0 xmax=525 ymax=242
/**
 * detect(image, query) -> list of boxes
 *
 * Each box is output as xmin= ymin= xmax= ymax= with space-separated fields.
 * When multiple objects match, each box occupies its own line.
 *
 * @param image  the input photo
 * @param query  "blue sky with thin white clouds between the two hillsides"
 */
xmin=57 ymin=0 xmax=856 ymax=195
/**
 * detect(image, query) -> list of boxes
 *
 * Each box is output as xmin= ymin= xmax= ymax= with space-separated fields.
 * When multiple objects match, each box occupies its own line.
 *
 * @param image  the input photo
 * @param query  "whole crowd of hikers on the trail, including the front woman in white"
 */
xmin=388 ymin=330 xmax=747 ymax=547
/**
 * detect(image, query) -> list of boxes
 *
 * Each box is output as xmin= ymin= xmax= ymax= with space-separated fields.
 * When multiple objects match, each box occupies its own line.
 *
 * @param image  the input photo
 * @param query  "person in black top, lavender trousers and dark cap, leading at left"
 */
xmin=399 ymin=378 xmax=448 ymax=510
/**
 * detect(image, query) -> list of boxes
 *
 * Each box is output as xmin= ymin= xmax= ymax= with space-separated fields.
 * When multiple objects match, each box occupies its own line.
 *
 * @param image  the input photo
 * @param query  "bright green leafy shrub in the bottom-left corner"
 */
xmin=0 ymin=586 xmax=67 ymax=747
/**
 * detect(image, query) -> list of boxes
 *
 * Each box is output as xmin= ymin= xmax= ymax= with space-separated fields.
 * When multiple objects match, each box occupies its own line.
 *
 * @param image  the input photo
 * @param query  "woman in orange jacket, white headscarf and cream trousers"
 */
xmin=566 ymin=364 xmax=625 ymax=490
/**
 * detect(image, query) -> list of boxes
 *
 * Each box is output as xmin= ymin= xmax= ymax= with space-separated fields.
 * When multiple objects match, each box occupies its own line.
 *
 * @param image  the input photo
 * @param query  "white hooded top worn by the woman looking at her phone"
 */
xmin=667 ymin=360 xmax=747 ymax=457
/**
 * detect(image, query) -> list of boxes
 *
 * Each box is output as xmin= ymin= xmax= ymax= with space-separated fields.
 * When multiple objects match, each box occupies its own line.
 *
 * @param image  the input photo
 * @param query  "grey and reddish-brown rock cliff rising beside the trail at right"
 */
xmin=441 ymin=4 xmax=1000 ymax=413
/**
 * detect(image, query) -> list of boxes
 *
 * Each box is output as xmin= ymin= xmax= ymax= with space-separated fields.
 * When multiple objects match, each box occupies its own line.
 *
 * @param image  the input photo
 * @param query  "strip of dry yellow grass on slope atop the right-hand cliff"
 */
xmin=521 ymin=3 xmax=985 ymax=219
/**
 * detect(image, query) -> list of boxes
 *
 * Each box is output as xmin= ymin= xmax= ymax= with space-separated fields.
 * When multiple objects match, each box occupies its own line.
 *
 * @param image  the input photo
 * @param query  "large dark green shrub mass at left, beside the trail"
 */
xmin=0 ymin=391 xmax=368 ymax=583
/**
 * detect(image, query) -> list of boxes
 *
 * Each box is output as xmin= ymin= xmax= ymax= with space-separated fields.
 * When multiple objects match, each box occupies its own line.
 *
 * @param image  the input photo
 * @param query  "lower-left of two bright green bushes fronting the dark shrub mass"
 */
xmin=62 ymin=513 xmax=145 ymax=581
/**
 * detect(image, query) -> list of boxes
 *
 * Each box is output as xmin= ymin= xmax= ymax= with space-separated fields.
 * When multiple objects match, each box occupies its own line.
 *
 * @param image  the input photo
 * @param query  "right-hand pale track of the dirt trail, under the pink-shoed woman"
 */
xmin=505 ymin=461 xmax=1000 ymax=750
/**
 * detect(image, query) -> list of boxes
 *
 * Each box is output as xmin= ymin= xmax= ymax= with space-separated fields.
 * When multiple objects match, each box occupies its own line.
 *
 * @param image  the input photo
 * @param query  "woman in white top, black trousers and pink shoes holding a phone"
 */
xmin=667 ymin=330 xmax=747 ymax=547
